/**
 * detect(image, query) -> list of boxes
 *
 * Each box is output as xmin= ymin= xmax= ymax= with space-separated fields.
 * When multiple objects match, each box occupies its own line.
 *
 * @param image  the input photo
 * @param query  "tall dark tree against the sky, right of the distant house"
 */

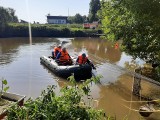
xmin=88 ymin=0 xmax=100 ymax=22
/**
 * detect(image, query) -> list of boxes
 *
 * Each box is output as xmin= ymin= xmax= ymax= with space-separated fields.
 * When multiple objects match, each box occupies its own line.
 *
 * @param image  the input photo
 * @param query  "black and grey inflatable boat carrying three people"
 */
xmin=40 ymin=56 xmax=92 ymax=80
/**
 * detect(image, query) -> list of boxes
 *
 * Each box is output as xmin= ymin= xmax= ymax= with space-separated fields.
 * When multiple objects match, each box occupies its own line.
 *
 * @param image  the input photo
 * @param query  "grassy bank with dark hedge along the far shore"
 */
xmin=0 ymin=23 xmax=99 ymax=37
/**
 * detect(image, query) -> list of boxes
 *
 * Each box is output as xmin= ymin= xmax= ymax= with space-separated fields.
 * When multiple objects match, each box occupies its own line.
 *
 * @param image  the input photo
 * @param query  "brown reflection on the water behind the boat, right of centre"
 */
xmin=72 ymin=38 xmax=121 ymax=63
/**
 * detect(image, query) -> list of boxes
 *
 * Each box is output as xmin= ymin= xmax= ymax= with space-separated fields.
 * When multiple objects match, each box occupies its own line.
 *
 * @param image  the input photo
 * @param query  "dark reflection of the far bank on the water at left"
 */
xmin=0 ymin=38 xmax=59 ymax=65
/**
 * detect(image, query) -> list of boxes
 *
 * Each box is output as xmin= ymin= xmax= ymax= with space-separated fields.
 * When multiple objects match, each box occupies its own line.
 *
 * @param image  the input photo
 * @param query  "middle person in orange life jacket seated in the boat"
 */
xmin=56 ymin=48 xmax=72 ymax=65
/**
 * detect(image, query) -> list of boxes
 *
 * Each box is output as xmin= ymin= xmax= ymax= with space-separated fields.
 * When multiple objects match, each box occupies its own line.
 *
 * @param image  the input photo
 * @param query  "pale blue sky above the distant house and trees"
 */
xmin=0 ymin=0 xmax=91 ymax=23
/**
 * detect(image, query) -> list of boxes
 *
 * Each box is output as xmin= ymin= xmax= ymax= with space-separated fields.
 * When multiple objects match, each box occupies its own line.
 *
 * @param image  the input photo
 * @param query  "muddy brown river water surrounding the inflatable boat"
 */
xmin=0 ymin=38 xmax=160 ymax=120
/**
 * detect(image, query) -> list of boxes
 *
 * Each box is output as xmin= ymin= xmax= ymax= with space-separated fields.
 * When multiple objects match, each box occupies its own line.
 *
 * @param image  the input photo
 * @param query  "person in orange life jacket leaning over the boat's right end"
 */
xmin=76 ymin=53 xmax=96 ymax=69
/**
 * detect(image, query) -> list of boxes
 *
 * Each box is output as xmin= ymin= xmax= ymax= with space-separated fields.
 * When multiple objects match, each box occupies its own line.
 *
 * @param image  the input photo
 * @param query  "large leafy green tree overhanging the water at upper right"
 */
xmin=98 ymin=0 xmax=160 ymax=67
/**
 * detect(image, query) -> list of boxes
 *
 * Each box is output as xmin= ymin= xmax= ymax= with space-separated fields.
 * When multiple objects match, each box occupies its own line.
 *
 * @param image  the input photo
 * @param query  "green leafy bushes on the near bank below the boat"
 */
xmin=7 ymin=76 xmax=106 ymax=120
